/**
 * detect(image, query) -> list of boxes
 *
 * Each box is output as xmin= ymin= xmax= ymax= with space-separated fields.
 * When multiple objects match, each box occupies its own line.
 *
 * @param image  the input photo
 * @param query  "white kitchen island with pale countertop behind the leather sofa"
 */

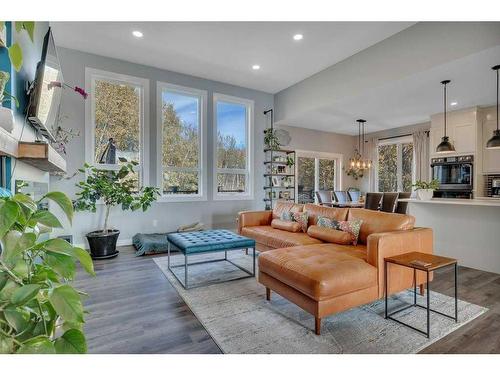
xmin=399 ymin=198 xmax=500 ymax=273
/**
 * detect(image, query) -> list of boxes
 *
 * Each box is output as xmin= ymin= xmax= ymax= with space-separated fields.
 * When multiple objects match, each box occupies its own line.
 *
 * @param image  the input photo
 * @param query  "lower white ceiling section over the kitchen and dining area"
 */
xmin=286 ymin=46 xmax=500 ymax=135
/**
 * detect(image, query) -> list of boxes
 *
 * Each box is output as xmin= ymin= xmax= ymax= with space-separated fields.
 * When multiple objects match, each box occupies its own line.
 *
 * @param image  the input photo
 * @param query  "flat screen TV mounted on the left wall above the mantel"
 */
xmin=28 ymin=28 xmax=63 ymax=141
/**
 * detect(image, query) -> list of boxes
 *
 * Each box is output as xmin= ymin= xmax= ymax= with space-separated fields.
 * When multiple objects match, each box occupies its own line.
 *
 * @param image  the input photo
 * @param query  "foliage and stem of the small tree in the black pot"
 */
xmin=75 ymin=162 xmax=159 ymax=233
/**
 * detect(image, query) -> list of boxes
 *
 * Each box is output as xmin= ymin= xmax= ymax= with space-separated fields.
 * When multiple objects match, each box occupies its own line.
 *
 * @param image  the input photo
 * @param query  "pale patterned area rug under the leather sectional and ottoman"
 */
xmin=153 ymin=251 xmax=488 ymax=354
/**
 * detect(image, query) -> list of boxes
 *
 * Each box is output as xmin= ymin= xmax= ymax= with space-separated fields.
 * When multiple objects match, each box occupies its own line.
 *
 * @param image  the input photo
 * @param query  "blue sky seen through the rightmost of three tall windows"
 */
xmin=217 ymin=101 xmax=246 ymax=148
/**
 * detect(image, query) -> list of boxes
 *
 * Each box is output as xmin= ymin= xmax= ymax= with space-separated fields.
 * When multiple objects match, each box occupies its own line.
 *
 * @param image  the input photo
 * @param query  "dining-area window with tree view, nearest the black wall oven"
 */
xmin=377 ymin=137 xmax=414 ymax=192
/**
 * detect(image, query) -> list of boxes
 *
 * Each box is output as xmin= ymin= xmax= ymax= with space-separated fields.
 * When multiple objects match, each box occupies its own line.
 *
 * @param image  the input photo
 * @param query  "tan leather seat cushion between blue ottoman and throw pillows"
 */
xmin=241 ymin=225 xmax=321 ymax=249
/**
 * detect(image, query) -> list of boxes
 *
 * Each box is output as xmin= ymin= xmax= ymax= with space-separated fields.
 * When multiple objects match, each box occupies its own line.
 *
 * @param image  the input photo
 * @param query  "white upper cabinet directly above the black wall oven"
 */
xmin=430 ymin=108 xmax=477 ymax=155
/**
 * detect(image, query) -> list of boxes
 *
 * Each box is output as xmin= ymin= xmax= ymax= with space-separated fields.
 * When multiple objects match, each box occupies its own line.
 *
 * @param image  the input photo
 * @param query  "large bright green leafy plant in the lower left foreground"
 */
xmin=0 ymin=192 xmax=94 ymax=353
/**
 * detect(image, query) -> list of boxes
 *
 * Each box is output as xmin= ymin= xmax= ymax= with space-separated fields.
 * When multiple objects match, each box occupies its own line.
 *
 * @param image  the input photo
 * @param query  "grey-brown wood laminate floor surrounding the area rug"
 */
xmin=75 ymin=246 xmax=500 ymax=353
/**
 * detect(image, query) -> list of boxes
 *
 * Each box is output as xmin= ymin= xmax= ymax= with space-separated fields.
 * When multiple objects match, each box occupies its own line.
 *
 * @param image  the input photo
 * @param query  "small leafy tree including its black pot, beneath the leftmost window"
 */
xmin=75 ymin=162 xmax=159 ymax=259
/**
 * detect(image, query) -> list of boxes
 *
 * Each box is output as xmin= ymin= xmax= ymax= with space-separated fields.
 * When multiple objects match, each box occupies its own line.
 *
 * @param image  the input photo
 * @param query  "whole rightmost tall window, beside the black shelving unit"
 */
xmin=214 ymin=96 xmax=251 ymax=196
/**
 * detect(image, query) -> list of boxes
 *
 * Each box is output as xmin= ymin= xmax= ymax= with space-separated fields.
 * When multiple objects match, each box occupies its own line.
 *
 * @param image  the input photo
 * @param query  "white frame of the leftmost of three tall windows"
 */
xmin=85 ymin=67 xmax=149 ymax=187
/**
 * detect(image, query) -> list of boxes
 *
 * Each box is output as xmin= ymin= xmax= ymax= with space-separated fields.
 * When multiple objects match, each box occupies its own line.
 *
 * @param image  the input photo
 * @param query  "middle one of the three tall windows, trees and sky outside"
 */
xmin=157 ymin=85 xmax=204 ymax=196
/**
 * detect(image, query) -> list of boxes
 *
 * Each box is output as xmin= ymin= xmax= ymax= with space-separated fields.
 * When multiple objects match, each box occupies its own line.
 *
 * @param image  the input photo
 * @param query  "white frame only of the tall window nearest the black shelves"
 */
xmin=213 ymin=93 xmax=255 ymax=201
